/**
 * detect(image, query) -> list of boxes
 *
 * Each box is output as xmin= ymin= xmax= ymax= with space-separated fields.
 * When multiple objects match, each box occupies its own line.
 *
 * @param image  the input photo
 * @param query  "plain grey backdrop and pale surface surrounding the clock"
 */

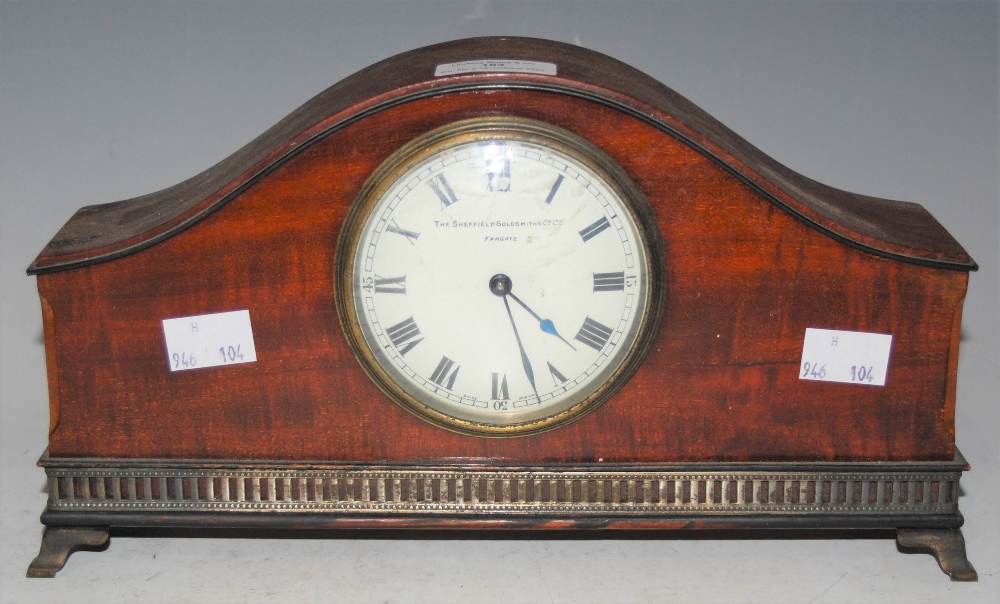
xmin=0 ymin=1 xmax=1000 ymax=602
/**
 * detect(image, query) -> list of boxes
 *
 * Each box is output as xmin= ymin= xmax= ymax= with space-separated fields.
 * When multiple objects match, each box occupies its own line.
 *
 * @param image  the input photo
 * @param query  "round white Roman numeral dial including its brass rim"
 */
xmin=338 ymin=118 xmax=659 ymax=436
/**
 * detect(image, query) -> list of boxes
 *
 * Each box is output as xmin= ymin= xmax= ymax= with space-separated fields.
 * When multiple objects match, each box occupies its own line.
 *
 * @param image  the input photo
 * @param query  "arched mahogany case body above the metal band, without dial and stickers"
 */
xmin=29 ymin=38 xmax=975 ymax=464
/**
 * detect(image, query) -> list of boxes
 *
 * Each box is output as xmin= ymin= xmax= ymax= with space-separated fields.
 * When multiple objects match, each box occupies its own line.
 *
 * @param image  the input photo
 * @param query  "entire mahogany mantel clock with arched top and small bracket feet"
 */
xmin=28 ymin=38 xmax=976 ymax=580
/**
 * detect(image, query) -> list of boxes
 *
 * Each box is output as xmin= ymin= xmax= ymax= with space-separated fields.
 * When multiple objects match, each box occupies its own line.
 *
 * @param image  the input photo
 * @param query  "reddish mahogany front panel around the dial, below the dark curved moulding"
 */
xmin=36 ymin=88 xmax=974 ymax=463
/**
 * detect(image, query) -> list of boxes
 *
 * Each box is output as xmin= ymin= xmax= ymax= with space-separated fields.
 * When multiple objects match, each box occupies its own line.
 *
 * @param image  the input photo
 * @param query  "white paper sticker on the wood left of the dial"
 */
xmin=163 ymin=310 xmax=257 ymax=371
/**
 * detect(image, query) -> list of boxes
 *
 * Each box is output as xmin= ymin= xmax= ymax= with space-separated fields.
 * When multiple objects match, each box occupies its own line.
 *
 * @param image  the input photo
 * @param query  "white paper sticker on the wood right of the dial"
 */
xmin=799 ymin=327 xmax=892 ymax=386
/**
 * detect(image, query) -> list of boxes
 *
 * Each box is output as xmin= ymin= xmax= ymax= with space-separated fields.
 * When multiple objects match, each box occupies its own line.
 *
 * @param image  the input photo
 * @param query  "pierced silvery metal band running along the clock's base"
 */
xmin=42 ymin=458 xmax=964 ymax=517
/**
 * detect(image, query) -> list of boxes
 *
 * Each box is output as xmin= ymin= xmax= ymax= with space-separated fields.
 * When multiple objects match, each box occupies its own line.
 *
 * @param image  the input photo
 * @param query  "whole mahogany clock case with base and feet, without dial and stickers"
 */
xmin=13 ymin=38 xmax=976 ymax=579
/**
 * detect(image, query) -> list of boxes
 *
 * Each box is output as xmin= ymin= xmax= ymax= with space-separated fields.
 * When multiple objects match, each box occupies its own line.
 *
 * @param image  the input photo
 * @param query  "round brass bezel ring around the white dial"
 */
xmin=334 ymin=116 xmax=666 ymax=438
